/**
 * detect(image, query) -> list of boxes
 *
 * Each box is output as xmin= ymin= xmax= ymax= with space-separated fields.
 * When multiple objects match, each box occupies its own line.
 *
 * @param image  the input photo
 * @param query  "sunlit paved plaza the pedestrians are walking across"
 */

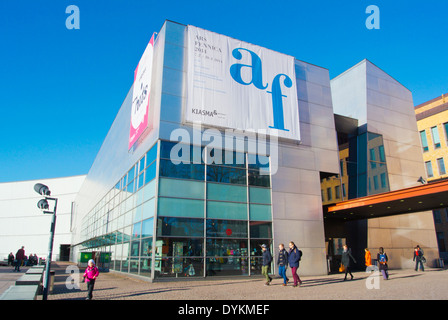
xmin=0 ymin=262 xmax=448 ymax=301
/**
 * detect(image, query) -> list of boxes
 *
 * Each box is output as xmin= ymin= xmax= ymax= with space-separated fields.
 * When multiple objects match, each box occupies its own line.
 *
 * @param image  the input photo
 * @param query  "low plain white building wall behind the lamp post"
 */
xmin=0 ymin=175 xmax=85 ymax=260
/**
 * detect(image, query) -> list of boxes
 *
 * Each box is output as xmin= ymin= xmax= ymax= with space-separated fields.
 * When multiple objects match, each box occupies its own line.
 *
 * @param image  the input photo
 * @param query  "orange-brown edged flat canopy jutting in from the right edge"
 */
xmin=325 ymin=180 xmax=448 ymax=220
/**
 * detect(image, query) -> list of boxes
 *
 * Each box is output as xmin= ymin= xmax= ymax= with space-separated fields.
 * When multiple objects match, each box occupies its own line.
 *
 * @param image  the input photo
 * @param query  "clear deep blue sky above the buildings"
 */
xmin=0 ymin=0 xmax=448 ymax=182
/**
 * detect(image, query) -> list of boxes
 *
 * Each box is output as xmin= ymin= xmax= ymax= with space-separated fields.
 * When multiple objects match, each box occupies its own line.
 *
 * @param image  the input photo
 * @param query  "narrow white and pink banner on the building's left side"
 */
xmin=129 ymin=34 xmax=155 ymax=150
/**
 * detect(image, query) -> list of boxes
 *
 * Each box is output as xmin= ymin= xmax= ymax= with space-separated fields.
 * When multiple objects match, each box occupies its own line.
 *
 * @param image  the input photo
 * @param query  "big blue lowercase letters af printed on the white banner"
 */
xmin=230 ymin=48 xmax=292 ymax=131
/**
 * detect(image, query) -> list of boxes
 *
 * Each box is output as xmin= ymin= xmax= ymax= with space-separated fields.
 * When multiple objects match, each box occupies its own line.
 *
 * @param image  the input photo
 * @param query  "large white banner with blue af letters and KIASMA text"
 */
xmin=184 ymin=26 xmax=300 ymax=140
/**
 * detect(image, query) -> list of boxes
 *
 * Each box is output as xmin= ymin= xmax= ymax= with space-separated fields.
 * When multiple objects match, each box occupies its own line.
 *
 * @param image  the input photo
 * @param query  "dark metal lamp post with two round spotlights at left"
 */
xmin=34 ymin=183 xmax=58 ymax=300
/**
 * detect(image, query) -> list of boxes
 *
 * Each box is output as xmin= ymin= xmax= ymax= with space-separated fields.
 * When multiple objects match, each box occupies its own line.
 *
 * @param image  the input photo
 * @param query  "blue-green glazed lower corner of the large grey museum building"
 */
xmin=77 ymin=141 xmax=273 ymax=278
